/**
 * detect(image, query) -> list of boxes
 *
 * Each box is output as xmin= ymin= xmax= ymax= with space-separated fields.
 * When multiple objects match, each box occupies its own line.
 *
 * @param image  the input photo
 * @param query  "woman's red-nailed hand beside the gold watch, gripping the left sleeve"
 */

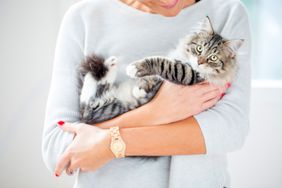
xmin=55 ymin=123 xmax=114 ymax=176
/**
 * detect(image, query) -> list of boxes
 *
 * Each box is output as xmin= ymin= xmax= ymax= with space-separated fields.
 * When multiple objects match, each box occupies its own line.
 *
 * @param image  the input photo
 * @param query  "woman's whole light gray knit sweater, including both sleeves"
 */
xmin=42 ymin=0 xmax=251 ymax=188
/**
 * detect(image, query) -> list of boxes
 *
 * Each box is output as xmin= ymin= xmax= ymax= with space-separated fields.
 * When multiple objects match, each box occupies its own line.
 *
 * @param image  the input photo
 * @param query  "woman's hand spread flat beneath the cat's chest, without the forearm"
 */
xmin=147 ymin=81 xmax=230 ymax=125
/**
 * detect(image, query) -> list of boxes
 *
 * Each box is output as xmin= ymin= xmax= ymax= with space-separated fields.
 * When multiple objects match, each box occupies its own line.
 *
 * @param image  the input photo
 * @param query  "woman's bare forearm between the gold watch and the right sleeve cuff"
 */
xmin=120 ymin=116 xmax=206 ymax=156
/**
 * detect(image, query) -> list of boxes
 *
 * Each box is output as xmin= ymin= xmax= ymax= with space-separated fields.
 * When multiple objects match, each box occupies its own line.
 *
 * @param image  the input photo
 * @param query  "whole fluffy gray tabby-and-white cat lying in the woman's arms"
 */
xmin=79 ymin=16 xmax=244 ymax=124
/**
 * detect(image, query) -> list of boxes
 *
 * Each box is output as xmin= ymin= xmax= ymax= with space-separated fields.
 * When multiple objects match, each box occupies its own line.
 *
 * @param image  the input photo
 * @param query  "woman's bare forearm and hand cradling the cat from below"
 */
xmin=95 ymin=81 xmax=231 ymax=128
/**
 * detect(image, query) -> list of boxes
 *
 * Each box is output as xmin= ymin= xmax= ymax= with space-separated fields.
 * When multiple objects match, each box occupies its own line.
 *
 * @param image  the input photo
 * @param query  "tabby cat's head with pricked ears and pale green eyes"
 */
xmin=180 ymin=17 xmax=244 ymax=85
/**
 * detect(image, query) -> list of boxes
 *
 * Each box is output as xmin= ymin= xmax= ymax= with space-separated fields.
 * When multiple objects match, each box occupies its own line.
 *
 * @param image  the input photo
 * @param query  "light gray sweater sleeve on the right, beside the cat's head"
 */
xmin=194 ymin=3 xmax=251 ymax=155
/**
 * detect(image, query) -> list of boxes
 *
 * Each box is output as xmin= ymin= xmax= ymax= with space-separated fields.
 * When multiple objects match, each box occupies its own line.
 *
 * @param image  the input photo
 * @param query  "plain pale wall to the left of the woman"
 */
xmin=0 ymin=0 xmax=73 ymax=188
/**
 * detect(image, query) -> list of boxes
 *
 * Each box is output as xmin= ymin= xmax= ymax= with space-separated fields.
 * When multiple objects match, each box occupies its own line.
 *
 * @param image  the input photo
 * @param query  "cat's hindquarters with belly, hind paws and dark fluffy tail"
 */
xmin=79 ymin=54 xmax=162 ymax=124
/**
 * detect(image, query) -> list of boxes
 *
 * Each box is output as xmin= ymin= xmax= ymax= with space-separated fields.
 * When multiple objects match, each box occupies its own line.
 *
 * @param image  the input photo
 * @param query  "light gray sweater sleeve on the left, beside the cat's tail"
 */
xmin=42 ymin=4 xmax=84 ymax=172
